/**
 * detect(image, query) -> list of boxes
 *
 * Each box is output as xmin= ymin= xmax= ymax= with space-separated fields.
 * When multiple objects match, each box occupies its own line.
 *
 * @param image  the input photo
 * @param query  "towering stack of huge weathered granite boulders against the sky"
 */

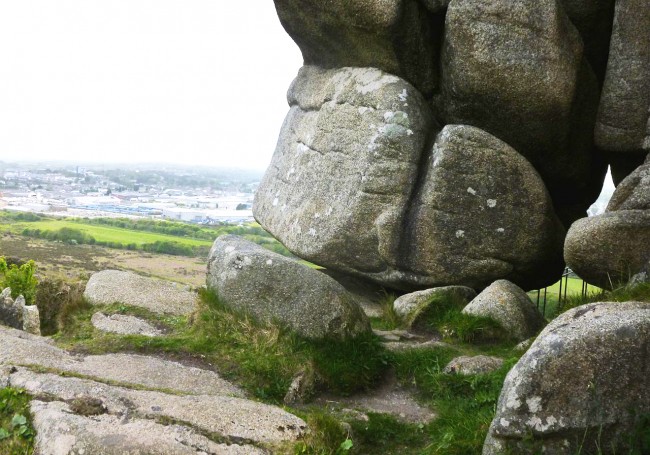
xmin=254 ymin=0 xmax=650 ymax=290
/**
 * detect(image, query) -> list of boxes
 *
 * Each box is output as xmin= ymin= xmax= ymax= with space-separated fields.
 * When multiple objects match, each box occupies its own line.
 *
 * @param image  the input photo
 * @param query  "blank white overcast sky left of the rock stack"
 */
xmin=0 ymin=0 xmax=302 ymax=169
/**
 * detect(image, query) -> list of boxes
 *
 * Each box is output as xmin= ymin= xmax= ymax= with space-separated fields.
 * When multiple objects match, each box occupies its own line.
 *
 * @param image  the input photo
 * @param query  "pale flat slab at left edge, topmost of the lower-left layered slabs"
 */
xmin=0 ymin=327 xmax=243 ymax=396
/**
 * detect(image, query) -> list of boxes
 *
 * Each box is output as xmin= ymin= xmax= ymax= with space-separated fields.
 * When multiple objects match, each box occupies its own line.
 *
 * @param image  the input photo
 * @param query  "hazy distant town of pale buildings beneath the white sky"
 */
xmin=0 ymin=162 xmax=261 ymax=225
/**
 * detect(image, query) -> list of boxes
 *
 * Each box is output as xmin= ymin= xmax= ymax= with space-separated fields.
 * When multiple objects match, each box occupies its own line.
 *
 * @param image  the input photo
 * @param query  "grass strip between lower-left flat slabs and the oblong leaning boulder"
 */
xmin=55 ymin=292 xmax=386 ymax=403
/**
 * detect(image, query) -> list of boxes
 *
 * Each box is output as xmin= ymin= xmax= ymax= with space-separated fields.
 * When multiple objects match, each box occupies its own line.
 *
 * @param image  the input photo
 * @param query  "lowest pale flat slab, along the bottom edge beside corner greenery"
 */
xmin=31 ymin=401 xmax=268 ymax=455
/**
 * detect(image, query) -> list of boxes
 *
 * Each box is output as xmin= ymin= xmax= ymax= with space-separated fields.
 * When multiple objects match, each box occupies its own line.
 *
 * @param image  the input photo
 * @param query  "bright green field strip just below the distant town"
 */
xmin=0 ymin=220 xmax=212 ymax=246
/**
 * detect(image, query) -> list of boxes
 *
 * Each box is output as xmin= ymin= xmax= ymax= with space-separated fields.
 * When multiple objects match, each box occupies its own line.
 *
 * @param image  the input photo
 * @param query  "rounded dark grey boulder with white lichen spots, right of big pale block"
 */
xmin=401 ymin=125 xmax=564 ymax=289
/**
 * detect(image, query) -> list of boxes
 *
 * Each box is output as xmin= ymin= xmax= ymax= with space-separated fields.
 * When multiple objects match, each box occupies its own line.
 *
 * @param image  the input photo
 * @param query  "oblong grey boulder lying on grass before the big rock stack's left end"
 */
xmin=207 ymin=235 xmax=370 ymax=339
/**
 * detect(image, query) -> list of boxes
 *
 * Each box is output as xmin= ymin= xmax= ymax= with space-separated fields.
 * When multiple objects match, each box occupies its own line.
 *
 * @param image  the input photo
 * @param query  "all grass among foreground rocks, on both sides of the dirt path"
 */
xmin=46 ymin=284 xmax=516 ymax=455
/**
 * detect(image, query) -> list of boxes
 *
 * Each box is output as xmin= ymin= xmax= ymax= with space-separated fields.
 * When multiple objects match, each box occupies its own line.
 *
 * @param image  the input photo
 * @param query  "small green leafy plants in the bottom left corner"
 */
xmin=0 ymin=387 xmax=35 ymax=455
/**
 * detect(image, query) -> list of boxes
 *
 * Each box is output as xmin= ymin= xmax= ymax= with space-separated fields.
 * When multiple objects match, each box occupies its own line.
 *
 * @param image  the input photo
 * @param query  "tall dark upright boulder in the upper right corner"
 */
xmin=595 ymin=0 xmax=650 ymax=153
